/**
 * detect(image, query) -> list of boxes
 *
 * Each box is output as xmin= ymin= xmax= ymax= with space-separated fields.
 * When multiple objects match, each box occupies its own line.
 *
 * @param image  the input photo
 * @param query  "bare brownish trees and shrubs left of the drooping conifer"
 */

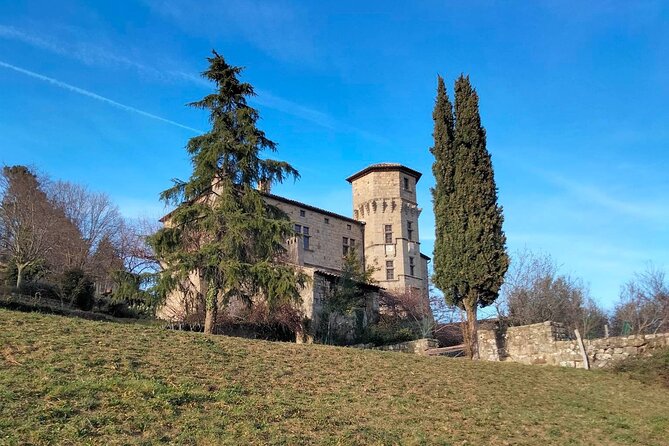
xmin=0 ymin=166 xmax=157 ymax=313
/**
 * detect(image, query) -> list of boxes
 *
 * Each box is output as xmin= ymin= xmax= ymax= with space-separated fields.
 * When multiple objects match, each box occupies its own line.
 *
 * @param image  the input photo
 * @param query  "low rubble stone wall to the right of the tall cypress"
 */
xmin=478 ymin=321 xmax=669 ymax=368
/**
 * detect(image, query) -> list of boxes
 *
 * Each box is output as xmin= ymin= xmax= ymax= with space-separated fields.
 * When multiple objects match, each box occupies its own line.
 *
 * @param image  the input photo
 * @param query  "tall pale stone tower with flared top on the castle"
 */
xmin=346 ymin=163 xmax=429 ymax=297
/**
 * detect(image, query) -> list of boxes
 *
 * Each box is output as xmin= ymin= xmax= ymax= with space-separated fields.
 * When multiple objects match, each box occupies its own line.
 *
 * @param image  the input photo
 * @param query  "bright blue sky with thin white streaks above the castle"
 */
xmin=0 ymin=0 xmax=669 ymax=307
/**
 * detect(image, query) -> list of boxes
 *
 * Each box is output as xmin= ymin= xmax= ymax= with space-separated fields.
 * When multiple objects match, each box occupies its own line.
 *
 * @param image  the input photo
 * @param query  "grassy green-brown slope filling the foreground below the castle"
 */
xmin=0 ymin=310 xmax=669 ymax=445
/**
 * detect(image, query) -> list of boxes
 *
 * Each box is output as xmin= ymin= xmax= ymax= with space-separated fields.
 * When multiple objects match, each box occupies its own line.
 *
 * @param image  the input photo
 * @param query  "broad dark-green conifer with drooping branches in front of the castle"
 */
xmin=150 ymin=51 xmax=305 ymax=333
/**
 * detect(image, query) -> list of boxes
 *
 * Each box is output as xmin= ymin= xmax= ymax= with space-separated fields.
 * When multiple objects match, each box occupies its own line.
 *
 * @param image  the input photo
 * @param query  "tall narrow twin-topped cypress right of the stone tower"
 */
xmin=432 ymin=75 xmax=509 ymax=358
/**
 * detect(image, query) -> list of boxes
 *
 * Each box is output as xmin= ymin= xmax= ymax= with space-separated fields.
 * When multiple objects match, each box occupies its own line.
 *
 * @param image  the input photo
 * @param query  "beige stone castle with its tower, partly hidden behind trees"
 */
xmin=158 ymin=163 xmax=430 ymax=342
